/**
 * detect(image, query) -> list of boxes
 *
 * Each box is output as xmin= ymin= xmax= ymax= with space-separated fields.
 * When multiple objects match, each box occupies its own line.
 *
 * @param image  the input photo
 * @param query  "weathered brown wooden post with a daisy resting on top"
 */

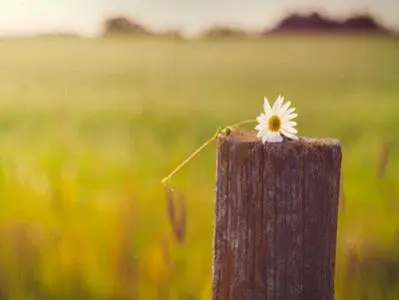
xmin=213 ymin=132 xmax=341 ymax=300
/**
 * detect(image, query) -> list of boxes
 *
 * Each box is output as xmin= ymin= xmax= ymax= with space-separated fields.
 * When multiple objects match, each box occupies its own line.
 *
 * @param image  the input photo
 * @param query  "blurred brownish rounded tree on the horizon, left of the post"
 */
xmin=104 ymin=16 xmax=150 ymax=35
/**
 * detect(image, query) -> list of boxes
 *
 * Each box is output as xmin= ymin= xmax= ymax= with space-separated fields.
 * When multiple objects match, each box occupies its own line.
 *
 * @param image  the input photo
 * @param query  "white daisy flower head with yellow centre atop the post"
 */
xmin=255 ymin=96 xmax=298 ymax=144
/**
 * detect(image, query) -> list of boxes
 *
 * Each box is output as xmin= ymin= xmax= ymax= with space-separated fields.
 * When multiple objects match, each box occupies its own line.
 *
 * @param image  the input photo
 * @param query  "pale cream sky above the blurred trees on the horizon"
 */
xmin=0 ymin=0 xmax=399 ymax=35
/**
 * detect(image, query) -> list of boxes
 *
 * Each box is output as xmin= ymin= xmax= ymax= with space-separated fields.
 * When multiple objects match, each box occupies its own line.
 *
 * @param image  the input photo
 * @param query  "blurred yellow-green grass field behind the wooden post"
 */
xmin=0 ymin=36 xmax=399 ymax=300
